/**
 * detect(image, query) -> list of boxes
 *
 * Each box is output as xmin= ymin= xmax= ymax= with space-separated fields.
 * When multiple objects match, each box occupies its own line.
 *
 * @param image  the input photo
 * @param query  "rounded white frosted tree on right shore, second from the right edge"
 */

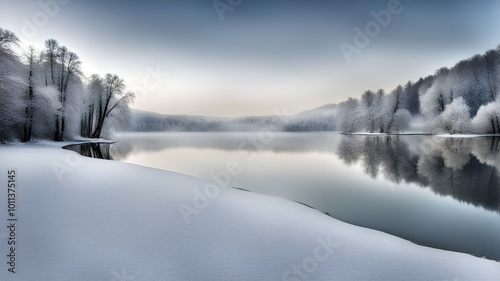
xmin=437 ymin=97 xmax=470 ymax=134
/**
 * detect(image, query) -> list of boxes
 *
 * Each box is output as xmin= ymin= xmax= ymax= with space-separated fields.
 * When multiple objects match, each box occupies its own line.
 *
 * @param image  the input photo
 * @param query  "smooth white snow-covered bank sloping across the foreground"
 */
xmin=0 ymin=144 xmax=500 ymax=281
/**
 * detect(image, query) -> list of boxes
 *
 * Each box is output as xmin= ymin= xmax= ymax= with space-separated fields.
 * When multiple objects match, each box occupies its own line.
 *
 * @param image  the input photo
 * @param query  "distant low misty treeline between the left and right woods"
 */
xmin=130 ymin=105 xmax=336 ymax=132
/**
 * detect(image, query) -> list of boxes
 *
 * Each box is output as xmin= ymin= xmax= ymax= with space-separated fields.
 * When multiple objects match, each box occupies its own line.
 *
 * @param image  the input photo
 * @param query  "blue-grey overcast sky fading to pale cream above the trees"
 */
xmin=0 ymin=0 xmax=500 ymax=116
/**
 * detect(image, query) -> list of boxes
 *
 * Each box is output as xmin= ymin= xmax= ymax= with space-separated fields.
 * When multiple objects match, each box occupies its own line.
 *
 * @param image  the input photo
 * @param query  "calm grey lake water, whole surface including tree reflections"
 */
xmin=64 ymin=133 xmax=500 ymax=260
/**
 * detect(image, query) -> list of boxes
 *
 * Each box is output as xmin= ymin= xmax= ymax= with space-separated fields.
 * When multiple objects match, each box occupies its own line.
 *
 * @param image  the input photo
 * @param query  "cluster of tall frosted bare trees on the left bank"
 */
xmin=0 ymin=28 xmax=134 ymax=142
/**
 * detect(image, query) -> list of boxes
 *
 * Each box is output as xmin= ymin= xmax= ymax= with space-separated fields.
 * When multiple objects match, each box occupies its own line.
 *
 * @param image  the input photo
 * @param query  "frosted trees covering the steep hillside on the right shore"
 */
xmin=338 ymin=46 xmax=500 ymax=134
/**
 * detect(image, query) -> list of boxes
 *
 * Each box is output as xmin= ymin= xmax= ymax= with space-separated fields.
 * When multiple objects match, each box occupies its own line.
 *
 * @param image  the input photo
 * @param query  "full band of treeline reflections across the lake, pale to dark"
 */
xmin=66 ymin=134 xmax=500 ymax=212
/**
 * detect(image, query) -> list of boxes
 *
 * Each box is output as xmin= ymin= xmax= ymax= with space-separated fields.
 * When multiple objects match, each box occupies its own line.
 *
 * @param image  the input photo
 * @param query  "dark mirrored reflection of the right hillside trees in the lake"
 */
xmin=337 ymin=136 xmax=500 ymax=212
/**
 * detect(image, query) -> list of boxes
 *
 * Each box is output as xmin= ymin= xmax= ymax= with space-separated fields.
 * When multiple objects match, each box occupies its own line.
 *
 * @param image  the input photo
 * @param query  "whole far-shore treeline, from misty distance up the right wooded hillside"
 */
xmin=135 ymin=46 xmax=500 ymax=134
